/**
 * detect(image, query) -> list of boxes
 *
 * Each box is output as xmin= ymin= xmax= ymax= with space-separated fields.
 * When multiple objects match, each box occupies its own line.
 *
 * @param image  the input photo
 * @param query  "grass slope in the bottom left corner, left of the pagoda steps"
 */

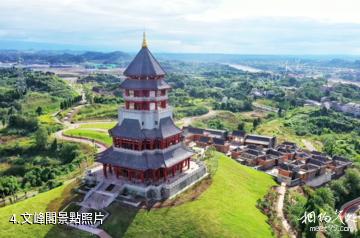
xmin=0 ymin=182 xmax=89 ymax=238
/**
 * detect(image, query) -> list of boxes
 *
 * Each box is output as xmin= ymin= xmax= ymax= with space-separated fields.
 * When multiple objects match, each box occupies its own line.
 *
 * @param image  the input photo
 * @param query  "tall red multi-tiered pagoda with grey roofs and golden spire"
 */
xmin=97 ymin=33 xmax=193 ymax=185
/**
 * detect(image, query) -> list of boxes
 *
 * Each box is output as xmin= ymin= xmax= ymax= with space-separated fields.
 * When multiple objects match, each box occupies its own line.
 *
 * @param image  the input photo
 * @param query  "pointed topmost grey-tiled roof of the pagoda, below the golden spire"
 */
xmin=124 ymin=45 xmax=165 ymax=77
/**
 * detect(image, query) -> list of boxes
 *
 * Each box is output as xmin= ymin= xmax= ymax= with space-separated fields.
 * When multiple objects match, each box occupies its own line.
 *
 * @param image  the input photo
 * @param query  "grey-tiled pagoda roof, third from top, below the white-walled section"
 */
xmin=109 ymin=117 xmax=181 ymax=140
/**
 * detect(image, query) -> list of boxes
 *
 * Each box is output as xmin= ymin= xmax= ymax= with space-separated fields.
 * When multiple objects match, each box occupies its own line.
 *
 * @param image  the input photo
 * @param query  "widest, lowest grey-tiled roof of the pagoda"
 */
xmin=97 ymin=144 xmax=194 ymax=170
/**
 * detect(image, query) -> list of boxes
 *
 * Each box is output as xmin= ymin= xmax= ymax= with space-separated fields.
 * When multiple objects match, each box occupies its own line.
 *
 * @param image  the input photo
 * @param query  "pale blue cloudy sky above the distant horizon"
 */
xmin=0 ymin=0 xmax=360 ymax=55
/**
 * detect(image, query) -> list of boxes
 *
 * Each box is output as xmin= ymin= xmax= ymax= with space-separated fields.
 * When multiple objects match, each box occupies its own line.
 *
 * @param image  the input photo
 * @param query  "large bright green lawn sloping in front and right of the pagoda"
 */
xmin=102 ymin=153 xmax=276 ymax=237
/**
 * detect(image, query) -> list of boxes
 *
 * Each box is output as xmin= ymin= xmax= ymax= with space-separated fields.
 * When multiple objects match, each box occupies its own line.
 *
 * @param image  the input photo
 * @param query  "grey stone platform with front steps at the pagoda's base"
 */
xmin=82 ymin=161 xmax=207 ymax=203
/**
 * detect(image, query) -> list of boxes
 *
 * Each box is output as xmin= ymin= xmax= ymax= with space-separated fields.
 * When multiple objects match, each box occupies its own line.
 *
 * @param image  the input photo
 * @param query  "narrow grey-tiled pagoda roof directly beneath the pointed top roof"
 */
xmin=120 ymin=79 xmax=171 ymax=90
